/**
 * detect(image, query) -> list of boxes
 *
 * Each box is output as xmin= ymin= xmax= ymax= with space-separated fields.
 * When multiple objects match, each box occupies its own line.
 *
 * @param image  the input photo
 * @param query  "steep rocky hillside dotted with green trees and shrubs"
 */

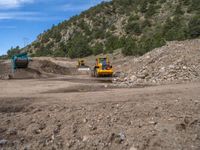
xmin=26 ymin=0 xmax=200 ymax=58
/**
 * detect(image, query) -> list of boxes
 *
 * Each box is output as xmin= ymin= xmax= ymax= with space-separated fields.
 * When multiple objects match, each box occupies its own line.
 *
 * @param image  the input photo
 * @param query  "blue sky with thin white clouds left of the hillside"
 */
xmin=0 ymin=0 xmax=104 ymax=55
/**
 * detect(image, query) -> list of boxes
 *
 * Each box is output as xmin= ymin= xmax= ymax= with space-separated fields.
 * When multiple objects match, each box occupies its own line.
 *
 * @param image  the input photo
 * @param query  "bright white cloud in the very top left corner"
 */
xmin=0 ymin=0 xmax=34 ymax=9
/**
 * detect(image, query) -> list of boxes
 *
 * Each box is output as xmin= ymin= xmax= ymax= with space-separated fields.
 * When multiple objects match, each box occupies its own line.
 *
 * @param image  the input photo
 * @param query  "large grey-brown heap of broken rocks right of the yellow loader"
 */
xmin=114 ymin=39 xmax=200 ymax=86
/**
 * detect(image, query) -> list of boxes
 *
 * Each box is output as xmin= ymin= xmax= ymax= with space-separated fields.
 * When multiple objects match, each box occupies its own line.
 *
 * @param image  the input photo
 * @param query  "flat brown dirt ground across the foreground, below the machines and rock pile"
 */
xmin=0 ymin=76 xmax=200 ymax=150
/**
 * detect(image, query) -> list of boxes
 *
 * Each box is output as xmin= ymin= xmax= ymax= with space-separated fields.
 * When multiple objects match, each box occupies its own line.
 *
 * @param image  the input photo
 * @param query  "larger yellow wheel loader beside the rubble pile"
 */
xmin=92 ymin=57 xmax=113 ymax=77
